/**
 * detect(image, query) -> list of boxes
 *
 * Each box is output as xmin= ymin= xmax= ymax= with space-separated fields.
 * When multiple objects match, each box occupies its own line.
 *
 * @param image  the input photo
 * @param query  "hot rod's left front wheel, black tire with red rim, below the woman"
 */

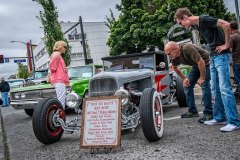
xmin=32 ymin=98 xmax=65 ymax=144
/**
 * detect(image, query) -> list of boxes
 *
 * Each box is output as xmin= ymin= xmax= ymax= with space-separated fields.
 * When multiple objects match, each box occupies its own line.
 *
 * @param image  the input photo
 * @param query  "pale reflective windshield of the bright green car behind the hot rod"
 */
xmin=68 ymin=66 xmax=93 ymax=79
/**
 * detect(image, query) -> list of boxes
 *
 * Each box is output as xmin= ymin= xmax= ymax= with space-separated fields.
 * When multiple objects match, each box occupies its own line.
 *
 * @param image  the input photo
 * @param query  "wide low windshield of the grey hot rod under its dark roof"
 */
xmin=103 ymin=55 xmax=154 ymax=71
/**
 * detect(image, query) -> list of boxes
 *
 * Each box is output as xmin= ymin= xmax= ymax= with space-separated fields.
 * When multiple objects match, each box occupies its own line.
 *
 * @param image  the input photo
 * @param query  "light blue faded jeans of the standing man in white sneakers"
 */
xmin=210 ymin=54 xmax=240 ymax=126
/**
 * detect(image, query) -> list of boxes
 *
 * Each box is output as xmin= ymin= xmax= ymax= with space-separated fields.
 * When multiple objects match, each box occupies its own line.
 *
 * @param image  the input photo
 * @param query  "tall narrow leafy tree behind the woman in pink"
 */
xmin=34 ymin=0 xmax=71 ymax=66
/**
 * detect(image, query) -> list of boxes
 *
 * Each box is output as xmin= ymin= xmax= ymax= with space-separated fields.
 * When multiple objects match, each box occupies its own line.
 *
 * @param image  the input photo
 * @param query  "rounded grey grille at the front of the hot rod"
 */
xmin=89 ymin=78 xmax=117 ymax=97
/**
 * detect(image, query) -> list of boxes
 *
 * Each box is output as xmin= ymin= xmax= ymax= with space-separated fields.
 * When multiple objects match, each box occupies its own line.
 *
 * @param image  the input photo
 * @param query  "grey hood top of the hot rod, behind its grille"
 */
xmin=91 ymin=69 xmax=153 ymax=83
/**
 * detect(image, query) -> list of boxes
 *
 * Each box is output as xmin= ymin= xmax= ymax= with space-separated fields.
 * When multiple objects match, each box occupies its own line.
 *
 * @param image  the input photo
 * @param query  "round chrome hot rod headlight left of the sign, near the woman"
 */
xmin=66 ymin=92 xmax=82 ymax=109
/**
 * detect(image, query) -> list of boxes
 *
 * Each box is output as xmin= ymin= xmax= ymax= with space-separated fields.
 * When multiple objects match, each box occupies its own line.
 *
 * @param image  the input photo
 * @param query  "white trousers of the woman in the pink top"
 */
xmin=54 ymin=83 xmax=66 ymax=109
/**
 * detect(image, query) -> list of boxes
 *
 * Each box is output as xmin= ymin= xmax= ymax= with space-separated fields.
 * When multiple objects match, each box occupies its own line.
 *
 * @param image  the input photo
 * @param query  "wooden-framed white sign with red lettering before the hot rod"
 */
xmin=80 ymin=96 xmax=121 ymax=148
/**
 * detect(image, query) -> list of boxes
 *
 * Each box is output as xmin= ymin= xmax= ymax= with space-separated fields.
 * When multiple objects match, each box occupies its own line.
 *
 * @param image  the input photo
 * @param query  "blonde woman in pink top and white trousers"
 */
xmin=49 ymin=41 xmax=69 ymax=109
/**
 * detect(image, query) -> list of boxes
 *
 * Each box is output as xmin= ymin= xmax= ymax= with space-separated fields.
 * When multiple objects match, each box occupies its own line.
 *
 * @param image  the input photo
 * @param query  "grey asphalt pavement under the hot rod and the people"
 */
xmin=0 ymin=89 xmax=240 ymax=160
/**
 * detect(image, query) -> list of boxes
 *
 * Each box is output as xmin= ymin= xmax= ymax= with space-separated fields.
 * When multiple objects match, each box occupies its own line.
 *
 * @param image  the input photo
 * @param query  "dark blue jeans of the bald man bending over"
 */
xmin=184 ymin=65 xmax=213 ymax=115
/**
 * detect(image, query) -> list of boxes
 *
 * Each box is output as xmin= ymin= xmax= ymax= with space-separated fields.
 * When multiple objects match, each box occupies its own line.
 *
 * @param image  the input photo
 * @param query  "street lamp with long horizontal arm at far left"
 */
xmin=10 ymin=39 xmax=35 ymax=75
